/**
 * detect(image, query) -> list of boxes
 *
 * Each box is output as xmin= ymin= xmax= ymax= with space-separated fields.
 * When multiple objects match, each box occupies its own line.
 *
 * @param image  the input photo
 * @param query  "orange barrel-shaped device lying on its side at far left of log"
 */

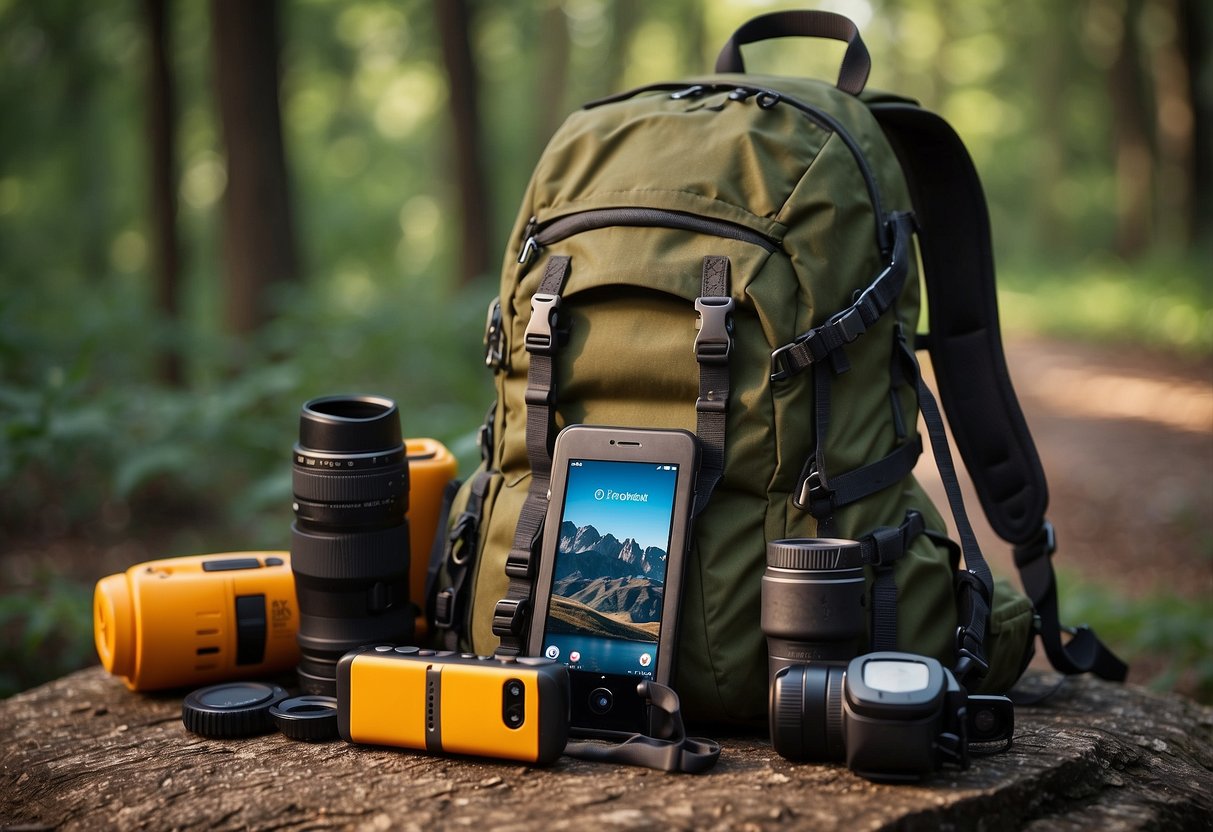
xmin=92 ymin=552 xmax=300 ymax=690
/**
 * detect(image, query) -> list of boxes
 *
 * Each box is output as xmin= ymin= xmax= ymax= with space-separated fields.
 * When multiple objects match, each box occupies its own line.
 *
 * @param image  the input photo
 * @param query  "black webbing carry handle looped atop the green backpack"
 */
xmin=716 ymin=11 xmax=872 ymax=96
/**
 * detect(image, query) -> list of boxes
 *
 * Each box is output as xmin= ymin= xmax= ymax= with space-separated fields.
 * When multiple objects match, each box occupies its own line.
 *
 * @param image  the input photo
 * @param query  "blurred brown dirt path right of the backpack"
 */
xmin=916 ymin=338 xmax=1213 ymax=598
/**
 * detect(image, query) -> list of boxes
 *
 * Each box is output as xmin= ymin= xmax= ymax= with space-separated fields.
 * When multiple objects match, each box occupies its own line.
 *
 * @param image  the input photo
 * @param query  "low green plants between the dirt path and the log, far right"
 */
xmin=1059 ymin=571 xmax=1213 ymax=703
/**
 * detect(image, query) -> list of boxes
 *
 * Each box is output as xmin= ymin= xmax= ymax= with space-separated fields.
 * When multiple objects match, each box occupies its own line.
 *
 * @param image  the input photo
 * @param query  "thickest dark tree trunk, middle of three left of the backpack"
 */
xmin=211 ymin=0 xmax=298 ymax=334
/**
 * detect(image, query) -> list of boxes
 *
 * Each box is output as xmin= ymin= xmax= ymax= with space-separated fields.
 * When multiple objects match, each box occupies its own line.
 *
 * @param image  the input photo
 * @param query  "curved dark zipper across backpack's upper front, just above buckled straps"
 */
xmin=518 ymin=207 xmax=779 ymax=266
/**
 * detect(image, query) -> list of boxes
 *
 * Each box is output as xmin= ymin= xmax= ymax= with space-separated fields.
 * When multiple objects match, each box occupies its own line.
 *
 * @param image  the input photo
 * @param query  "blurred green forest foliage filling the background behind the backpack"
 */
xmin=0 ymin=0 xmax=1213 ymax=698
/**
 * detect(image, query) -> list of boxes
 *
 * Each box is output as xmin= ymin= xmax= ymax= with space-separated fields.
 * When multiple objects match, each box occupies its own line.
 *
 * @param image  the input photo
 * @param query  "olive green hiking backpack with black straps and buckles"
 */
xmin=427 ymin=12 xmax=1126 ymax=720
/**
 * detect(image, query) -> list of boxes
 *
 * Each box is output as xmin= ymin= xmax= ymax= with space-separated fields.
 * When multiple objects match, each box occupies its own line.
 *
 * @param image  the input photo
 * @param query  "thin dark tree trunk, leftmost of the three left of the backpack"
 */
xmin=143 ymin=0 xmax=182 ymax=386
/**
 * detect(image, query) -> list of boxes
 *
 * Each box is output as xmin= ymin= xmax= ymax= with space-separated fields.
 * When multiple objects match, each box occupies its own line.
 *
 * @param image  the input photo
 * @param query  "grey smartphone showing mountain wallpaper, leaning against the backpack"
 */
xmin=528 ymin=424 xmax=699 ymax=734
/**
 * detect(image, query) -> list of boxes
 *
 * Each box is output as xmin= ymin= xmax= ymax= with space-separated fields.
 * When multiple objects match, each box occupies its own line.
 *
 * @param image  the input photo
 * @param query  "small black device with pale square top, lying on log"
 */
xmin=770 ymin=651 xmax=1015 ymax=781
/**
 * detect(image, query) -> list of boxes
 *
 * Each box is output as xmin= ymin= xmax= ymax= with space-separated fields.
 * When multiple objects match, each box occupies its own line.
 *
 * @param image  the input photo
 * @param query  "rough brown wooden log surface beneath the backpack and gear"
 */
xmin=0 ymin=667 xmax=1213 ymax=832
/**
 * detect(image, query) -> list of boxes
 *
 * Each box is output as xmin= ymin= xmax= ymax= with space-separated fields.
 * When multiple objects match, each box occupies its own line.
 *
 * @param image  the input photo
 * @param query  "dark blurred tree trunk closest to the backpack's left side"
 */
xmin=433 ymin=0 xmax=492 ymax=285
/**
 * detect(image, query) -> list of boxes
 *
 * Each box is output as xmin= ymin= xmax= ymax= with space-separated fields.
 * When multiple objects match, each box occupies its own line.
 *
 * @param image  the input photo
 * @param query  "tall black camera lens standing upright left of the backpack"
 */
xmin=291 ymin=397 xmax=414 ymax=696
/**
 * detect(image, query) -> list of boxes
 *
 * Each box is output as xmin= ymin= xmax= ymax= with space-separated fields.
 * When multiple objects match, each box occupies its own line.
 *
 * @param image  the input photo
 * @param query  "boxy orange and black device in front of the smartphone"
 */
xmin=337 ymin=644 xmax=569 ymax=765
